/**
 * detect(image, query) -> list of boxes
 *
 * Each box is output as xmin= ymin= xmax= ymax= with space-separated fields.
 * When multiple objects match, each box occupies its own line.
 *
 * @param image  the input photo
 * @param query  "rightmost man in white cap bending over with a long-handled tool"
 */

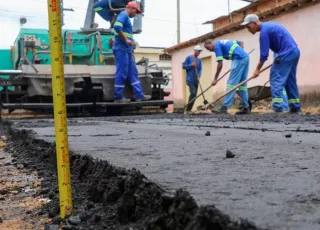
xmin=242 ymin=14 xmax=301 ymax=113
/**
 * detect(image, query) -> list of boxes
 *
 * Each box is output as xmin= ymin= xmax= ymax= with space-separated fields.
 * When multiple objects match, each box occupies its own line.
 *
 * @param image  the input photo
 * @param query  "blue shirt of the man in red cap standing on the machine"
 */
xmin=112 ymin=11 xmax=134 ymax=53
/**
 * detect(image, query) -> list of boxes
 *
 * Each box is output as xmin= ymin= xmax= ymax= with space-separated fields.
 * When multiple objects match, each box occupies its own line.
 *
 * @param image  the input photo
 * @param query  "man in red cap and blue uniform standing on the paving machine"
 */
xmin=112 ymin=2 xmax=151 ymax=103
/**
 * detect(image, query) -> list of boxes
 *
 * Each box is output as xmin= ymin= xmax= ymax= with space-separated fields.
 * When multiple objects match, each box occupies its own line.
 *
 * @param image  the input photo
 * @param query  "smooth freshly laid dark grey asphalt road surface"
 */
xmin=11 ymin=115 xmax=320 ymax=230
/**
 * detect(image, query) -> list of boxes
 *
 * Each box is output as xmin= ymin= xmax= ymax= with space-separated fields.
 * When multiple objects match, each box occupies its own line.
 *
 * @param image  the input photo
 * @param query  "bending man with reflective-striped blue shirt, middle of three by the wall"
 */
xmin=205 ymin=40 xmax=250 ymax=114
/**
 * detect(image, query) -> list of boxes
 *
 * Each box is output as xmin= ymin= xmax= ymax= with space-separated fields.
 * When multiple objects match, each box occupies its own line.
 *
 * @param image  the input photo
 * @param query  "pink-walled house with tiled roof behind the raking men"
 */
xmin=164 ymin=0 xmax=320 ymax=108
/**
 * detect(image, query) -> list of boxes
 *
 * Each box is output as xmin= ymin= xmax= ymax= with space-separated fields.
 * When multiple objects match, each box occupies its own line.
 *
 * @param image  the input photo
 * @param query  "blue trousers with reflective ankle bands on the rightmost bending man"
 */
xmin=270 ymin=48 xmax=301 ymax=112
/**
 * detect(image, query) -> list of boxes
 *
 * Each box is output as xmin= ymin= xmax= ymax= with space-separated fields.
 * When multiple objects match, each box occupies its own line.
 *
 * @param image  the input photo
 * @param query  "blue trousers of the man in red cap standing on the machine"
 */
xmin=114 ymin=50 xmax=144 ymax=100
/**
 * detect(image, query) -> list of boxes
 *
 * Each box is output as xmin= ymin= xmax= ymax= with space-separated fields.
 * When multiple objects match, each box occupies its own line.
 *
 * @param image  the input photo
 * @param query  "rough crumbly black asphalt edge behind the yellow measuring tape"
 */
xmin=2 ymin=126 xmax=259 ymax=230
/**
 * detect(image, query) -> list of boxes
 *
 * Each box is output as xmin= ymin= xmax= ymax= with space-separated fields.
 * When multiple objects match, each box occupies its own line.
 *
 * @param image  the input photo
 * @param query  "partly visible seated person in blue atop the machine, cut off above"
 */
xmin=93 ymin=0 xmax=132 ymax=28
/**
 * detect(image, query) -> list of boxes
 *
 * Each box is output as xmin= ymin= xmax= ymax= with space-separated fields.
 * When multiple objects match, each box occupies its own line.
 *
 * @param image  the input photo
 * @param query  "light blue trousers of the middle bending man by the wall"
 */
xmin=223 ymin=57 xmax=249 ymax=108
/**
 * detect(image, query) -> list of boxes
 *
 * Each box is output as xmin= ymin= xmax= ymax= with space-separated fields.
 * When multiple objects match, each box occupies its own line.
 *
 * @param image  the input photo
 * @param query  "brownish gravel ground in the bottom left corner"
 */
xmin=0 ymin=135 xmax=51 ymax=230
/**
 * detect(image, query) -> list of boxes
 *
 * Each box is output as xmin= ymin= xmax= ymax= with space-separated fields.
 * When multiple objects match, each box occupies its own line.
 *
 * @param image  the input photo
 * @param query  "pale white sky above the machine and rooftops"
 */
xmin=0 ymin=0 xmax=249 ymax=49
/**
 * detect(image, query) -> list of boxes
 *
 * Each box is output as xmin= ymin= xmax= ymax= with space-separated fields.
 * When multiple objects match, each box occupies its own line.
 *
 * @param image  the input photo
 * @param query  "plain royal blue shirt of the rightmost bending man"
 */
xmin=260 ymin=22 xmax=298 ymax=62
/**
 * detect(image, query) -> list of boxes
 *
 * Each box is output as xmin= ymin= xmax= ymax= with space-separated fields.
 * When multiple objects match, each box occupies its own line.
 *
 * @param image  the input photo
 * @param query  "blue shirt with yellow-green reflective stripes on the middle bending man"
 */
xmin=213 ymin=40 xmax=248 ymax=61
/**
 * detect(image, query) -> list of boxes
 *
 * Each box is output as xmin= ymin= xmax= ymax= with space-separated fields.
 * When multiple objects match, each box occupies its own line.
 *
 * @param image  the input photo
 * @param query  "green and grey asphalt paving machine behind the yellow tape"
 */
xmin=0 ymin=0 xmax=173 ymax=114
